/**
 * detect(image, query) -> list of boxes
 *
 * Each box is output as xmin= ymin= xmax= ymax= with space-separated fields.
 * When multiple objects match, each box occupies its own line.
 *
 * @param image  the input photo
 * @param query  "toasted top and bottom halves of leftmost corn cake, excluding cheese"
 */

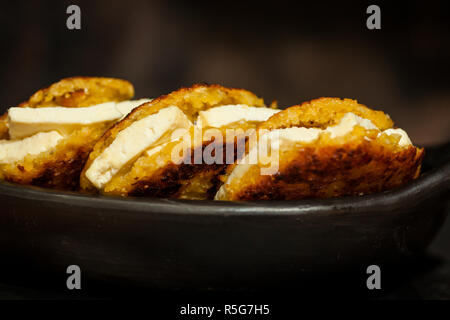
xmin=0 ymin=77 xmax=134 ymax=190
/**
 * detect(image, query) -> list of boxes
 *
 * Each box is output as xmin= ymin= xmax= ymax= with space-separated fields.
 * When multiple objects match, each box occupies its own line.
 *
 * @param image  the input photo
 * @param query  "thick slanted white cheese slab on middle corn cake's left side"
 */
xmin=86 ymin=106 xmax=192 ymax=189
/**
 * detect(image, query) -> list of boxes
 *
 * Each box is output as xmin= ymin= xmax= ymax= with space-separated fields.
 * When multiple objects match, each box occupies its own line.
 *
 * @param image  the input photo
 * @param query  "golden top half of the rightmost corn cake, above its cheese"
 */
xmin=259 ymin=98 xmax=394 ymax=130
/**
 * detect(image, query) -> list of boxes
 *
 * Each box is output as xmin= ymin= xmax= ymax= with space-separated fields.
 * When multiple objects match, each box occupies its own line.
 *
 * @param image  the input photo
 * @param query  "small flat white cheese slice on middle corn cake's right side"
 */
xmin=196 ymin=104 xmax=281 ymax=128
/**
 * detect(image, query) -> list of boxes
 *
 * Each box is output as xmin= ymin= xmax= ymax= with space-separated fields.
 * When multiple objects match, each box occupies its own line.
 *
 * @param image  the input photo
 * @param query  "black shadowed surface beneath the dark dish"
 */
xmin=0 ymin=254 xmax=450 ymax=304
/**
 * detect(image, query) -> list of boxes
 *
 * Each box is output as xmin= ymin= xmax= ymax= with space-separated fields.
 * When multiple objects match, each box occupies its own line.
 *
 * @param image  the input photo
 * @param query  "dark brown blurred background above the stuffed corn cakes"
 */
xmin=0 ymin=0 xmax=450 ymax=145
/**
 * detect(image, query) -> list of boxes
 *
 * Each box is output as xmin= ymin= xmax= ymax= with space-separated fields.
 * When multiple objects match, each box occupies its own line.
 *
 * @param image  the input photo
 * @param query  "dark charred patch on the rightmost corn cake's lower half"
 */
xmin=236 ymin=146 xmax=424 ymax=200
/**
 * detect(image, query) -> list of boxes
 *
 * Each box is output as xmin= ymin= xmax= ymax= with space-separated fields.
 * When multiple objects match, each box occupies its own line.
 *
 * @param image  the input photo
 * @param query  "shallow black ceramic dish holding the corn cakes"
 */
xmin=0 ymin=144 xmax=450 ymax=288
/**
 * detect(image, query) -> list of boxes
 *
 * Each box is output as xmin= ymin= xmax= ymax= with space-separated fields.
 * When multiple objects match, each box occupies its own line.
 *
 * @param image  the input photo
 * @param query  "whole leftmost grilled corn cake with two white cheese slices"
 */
xmin=0 ymin=77 xmax=148 ymax=190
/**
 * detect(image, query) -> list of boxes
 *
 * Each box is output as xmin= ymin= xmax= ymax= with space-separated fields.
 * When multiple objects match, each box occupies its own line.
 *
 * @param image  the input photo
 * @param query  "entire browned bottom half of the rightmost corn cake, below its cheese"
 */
xmin=216 ymin=128 xmax=424 ymax=200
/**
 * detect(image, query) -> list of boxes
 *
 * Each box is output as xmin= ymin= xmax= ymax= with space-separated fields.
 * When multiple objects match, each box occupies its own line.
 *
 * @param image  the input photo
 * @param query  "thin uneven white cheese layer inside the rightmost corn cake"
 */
xmin=215 ymin=112 xmax=412 ymax=200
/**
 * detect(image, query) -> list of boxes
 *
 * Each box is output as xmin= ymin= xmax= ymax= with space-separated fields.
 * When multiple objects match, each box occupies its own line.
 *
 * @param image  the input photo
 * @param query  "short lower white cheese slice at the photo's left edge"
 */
xmin=0 ymin=131 xmax=63 ymax=163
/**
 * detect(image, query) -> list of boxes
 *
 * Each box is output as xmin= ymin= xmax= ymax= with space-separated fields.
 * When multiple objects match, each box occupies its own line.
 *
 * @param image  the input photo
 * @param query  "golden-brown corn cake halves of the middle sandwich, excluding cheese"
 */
xmin=81 ymin=85 xmax=265 ymax=199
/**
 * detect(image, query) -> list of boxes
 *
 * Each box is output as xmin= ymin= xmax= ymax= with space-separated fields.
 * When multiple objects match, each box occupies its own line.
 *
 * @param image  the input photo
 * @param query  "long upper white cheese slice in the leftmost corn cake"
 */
xmin=8 ymin=99 xmax=149 ymax=139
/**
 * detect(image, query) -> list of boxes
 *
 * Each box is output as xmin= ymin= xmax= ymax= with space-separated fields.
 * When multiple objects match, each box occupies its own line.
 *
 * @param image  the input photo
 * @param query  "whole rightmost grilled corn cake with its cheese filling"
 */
xmin=215 ymin=98 xmax=424 ymax=200
